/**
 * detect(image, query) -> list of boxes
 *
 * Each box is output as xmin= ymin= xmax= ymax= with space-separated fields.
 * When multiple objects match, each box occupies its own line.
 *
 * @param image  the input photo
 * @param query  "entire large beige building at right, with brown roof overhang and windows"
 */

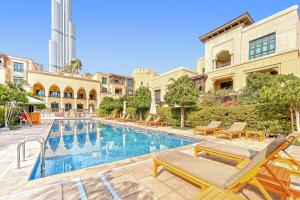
xmin=197 ymin=6 xmax=300 ymax=91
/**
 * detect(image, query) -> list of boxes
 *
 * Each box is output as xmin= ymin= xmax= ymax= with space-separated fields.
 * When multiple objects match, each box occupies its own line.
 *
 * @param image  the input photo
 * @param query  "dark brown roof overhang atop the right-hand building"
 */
xmin=199 ymin=12 xmax=254 ymax=42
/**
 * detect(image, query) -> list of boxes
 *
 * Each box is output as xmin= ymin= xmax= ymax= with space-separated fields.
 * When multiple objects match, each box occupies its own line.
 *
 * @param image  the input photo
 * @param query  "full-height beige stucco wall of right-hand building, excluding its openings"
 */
xmin=205 ymin=6 xmax=300 ymax=91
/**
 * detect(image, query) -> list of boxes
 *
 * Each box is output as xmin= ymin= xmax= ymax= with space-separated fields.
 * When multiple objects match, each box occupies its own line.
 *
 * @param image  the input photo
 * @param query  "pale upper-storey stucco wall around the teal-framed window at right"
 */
xmin=205 ymin=6 xmax=299 ymax=72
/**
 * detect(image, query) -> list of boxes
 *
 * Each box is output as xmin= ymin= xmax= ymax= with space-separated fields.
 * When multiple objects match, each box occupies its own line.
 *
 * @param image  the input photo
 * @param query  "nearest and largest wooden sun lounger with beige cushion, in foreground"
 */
xmin=153 ymin=135 xmax=292 ymax=200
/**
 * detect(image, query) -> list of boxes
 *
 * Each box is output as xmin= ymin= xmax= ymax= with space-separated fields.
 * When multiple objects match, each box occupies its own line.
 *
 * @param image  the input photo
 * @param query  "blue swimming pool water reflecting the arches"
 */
xmin=30 ymin=120 xmax=196 ymax=180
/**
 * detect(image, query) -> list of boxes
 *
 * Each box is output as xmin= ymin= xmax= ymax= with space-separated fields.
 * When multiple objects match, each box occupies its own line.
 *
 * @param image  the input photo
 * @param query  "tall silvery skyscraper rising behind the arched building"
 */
xmin=49 ymin=0 xmax=76 ymax=72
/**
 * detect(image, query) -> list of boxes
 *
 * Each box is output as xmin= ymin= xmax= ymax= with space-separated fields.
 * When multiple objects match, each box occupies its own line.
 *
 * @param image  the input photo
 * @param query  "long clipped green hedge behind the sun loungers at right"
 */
xmin=158 ymin=104 xmax=291 ymax=134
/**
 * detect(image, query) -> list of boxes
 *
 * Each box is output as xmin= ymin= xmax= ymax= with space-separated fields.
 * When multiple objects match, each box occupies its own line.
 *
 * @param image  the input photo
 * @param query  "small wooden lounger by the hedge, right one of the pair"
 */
xmin=216 ymin=122 xmax=247 ymax=140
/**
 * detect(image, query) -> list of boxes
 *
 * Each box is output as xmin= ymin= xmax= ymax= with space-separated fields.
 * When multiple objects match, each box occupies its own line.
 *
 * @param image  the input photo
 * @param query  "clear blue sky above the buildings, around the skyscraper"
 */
xmin=0 ymin=0 xmax=300 ymax=75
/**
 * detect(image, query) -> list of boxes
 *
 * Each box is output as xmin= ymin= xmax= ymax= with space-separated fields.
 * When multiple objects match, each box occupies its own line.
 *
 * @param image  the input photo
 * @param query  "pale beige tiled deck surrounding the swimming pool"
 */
xmin=0 ymin=121 xmax=300 ymax=200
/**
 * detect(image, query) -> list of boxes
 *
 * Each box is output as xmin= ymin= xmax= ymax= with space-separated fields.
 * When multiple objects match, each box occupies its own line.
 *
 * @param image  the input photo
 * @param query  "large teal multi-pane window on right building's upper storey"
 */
xmin=249 ymin=33 xmax=276 ymax=60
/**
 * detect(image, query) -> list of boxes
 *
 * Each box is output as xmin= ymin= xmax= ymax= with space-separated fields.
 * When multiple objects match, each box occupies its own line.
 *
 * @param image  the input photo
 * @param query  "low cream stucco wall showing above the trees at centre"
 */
xmin=150 ymin=67 xmax=197 ymax=101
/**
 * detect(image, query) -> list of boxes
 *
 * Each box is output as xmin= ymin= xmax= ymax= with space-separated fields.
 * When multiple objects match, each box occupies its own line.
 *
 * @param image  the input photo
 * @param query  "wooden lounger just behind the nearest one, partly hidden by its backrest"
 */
xmin=194 ymin=133 xmax=300 ymax=177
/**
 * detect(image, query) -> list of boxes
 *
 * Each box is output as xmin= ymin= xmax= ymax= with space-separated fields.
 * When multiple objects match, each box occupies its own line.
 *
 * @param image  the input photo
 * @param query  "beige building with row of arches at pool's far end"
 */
xmin=0 ymin=54 xmax=134 ymax=111
